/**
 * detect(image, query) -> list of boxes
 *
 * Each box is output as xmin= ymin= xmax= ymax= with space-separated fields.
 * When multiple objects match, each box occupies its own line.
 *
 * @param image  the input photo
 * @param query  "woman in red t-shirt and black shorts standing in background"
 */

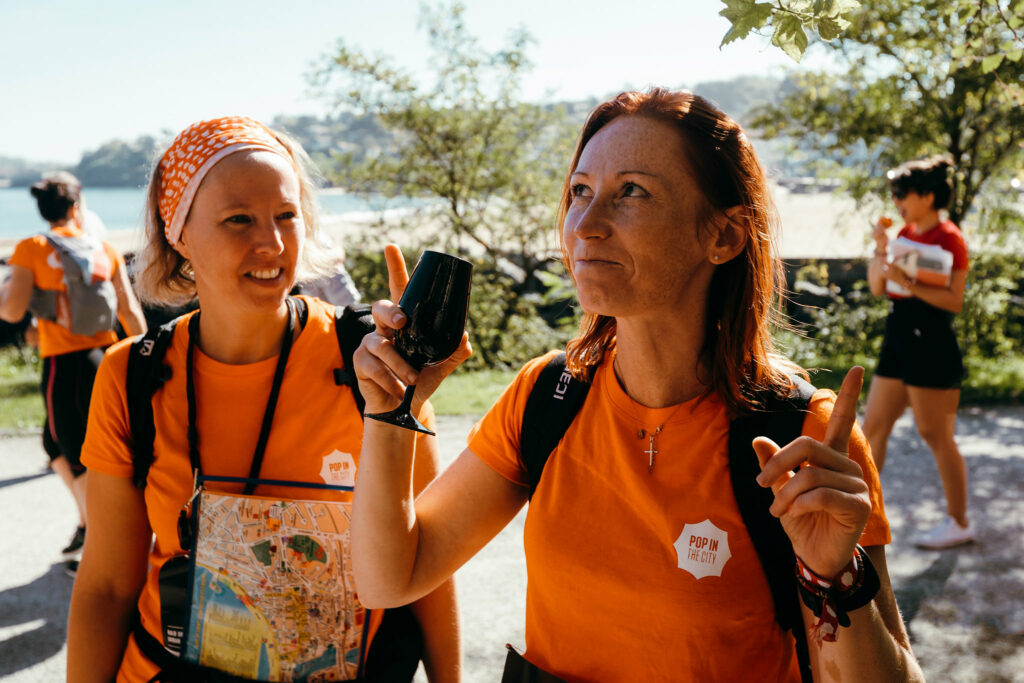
xmin=864 ymin=157 xmax=974 ymax=549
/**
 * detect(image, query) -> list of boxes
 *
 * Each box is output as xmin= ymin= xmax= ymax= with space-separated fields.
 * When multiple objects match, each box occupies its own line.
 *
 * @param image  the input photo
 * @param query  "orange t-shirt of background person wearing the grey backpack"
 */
xmin=8 ymin=227 xmax=125 ymax=358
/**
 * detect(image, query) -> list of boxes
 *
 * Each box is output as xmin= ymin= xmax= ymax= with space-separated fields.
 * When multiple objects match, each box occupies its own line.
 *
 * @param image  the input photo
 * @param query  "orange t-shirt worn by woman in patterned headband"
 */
xmin=82 ymin=297 xmax=433 ymax=682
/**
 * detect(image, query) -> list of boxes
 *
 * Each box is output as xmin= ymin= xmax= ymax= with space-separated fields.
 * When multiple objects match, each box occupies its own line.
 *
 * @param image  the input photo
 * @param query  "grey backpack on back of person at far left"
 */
xmin=29 ymin=232 xmax=118 ymax=336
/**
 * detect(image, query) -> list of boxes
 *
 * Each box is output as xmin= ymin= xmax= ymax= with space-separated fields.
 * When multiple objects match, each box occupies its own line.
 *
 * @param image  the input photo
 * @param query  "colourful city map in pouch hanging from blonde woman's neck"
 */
xmin=183 ymin=489 xmax=368 ymax=681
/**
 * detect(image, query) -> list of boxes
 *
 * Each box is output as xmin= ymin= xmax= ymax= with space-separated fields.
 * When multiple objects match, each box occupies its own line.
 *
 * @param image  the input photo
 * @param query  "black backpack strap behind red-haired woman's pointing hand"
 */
xmin=729 ymin=377 xmax=815 ymax=681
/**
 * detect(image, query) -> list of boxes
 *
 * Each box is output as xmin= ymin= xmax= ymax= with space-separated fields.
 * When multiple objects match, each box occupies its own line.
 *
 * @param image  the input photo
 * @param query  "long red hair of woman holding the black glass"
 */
xmin=557 ymin=88 xmax=800 ymax=415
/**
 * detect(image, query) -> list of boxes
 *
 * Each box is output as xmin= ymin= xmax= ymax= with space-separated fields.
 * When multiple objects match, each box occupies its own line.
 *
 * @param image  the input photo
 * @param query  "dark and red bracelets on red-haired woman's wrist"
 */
xmin=797 ymin=546 xmax=881 ymax=647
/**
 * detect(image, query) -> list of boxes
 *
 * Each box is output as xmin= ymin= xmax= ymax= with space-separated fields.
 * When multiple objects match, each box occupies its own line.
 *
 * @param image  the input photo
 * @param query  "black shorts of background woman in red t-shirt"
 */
xmin=874 ymin=299 xmax=964 ymax=389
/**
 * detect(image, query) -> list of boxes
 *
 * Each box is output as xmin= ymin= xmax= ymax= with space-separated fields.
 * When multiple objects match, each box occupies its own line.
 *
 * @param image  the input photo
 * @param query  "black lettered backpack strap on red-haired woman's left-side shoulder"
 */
xmin=519 ymin=353 xmax=590 ymax=498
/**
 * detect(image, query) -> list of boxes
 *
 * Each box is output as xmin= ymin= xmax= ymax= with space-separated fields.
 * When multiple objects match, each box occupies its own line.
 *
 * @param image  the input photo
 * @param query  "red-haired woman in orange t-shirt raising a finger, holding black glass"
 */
xmin=353 ymin=89 xmax=921 ymax=682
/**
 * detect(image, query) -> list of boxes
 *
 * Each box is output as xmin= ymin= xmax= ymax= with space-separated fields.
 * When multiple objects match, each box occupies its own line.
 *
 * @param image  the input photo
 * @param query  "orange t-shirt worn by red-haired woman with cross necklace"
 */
xmin=468 ymin=351 xmax=890 ymax=683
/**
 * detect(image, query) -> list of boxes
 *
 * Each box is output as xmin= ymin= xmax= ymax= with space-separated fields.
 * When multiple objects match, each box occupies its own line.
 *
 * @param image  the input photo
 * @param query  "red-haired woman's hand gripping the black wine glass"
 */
xmin=352 ymin=245 xmax=472 ymax=415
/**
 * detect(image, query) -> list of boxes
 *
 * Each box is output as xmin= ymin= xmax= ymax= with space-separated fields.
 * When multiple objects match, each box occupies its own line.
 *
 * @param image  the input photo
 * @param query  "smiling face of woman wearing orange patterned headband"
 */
xmin=179 ymin=151 xmax=305 ymax=310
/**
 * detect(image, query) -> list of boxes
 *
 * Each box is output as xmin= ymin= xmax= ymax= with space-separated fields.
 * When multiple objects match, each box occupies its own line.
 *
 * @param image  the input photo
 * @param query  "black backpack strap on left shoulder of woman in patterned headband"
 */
xmin=125 ymin=318 xmax=180 ymax=488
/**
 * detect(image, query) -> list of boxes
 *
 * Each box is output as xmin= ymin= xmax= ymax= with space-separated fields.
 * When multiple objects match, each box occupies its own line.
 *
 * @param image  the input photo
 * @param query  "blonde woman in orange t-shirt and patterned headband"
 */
xmin=68 ymin=117 xmax=461 ymax=683
